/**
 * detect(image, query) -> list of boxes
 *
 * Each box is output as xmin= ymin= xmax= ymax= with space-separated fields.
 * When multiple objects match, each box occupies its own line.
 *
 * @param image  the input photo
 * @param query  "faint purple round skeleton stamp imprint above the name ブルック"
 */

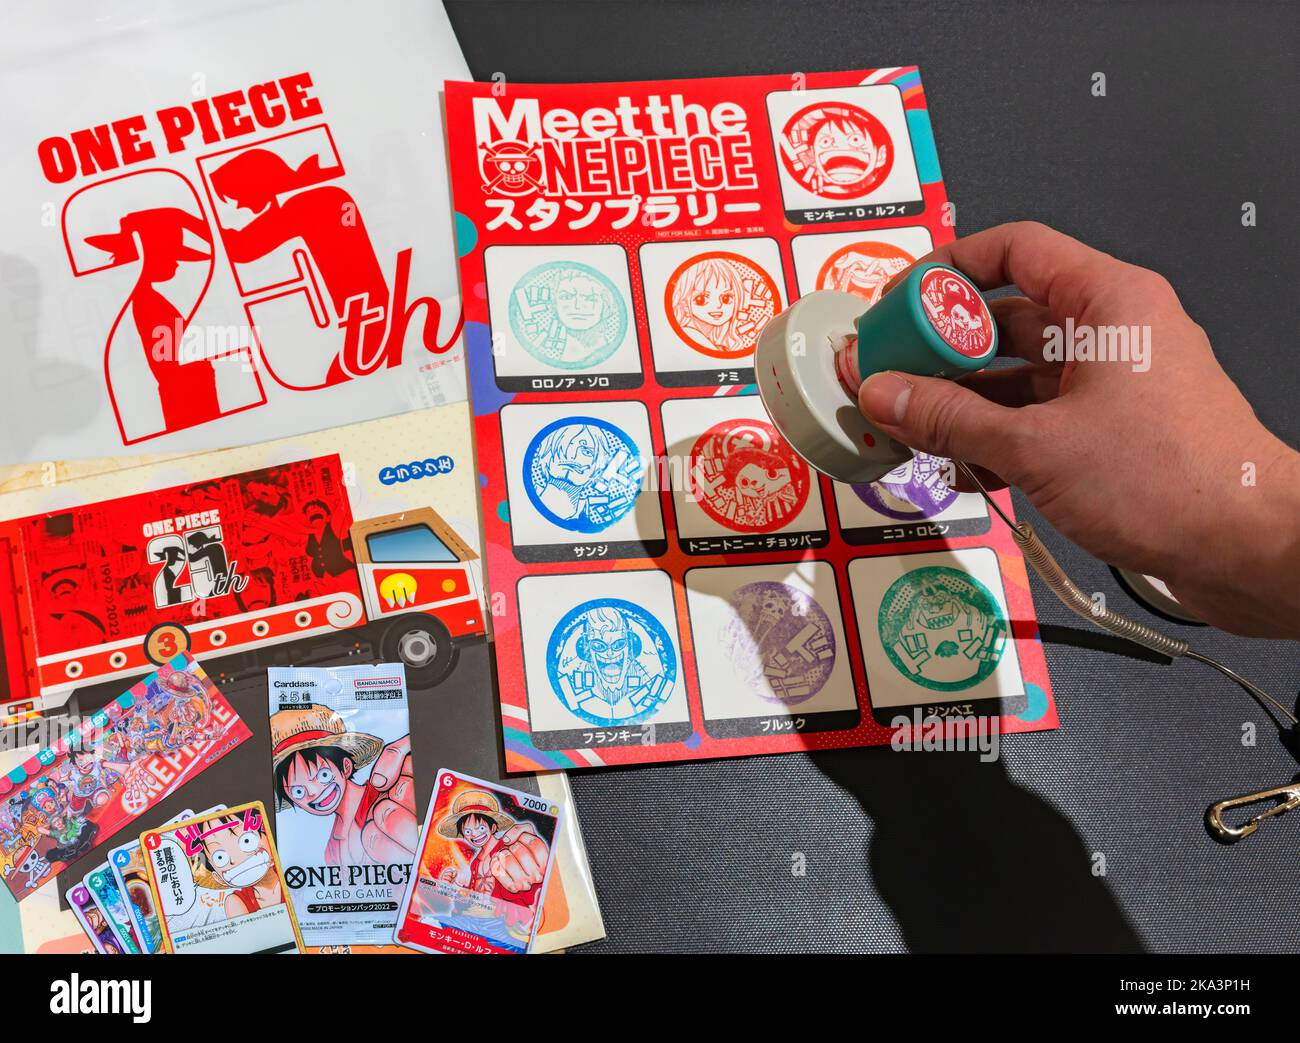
xmin=722 ymin=581 xmax=836 ymax=706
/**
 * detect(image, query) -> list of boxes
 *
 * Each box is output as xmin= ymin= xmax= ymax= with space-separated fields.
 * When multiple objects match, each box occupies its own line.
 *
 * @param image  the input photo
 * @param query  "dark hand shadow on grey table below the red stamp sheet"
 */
xmin=810 ymin=748 xmax=1143 ymax=952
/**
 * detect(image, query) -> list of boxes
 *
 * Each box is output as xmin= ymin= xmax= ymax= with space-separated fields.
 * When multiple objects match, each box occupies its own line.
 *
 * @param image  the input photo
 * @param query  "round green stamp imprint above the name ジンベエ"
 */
xmin=876 ymin=566 xmax=1008 ymax=692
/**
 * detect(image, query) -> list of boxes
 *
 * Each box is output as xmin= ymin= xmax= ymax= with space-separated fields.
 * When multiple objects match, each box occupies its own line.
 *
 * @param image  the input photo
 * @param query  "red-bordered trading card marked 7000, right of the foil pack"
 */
xmin=394 ymin=769 xmax=560 ymax=953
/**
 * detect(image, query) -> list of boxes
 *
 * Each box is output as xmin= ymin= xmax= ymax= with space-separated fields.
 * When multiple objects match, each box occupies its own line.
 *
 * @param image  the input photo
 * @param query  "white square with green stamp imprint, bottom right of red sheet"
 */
xmin=849 ymin=548 xmax=1028 ymax=726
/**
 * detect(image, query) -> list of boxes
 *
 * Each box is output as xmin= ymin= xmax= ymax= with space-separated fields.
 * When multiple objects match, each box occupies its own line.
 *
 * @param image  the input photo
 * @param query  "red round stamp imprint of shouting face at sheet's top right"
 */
xmin=779 ymin=101 xmax=893 ymax=199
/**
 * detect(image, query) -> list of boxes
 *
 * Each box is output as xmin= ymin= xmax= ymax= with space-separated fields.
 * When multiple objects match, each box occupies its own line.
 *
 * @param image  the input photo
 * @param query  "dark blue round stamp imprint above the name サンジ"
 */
xmin=524 ymin=416 xmax=646 ymax=533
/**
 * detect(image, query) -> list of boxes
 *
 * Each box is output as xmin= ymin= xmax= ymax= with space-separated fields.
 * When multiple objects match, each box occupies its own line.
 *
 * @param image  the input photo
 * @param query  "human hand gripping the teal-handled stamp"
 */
xmin=858 ymin=222 xmax=1300 ymax=637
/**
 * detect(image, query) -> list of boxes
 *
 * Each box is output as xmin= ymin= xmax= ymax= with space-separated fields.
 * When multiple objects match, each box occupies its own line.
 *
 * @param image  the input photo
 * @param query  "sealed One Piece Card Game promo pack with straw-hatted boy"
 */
xmin=267 ymin=663 xmax=419 ymax=945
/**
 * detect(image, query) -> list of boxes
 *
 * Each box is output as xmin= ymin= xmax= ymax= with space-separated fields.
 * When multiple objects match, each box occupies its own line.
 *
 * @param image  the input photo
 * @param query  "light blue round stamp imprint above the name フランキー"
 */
xmin=546 ymin=597 xmax=677 ymax=727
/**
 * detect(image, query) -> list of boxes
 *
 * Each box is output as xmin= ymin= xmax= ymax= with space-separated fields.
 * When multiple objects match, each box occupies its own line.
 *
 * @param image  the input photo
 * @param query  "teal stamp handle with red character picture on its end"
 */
xmin=837 ymin=261 xmax=997 ymax=397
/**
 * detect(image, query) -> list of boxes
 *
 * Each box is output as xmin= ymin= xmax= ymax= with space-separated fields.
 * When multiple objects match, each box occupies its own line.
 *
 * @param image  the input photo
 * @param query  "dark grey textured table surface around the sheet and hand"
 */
xmin=447 ymin=0 xmax=1300 ymax=952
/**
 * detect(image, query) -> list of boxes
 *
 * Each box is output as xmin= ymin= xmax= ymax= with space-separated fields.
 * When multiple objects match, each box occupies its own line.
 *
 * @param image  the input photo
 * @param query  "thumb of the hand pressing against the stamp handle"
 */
xmin=858 ymin=371 xmax=1026 ymax=484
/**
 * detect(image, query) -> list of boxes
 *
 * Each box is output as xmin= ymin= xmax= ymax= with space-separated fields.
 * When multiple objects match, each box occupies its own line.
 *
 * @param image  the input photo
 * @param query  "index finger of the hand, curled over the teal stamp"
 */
xmin=885 ymin=221 xmax=1128 ymax=316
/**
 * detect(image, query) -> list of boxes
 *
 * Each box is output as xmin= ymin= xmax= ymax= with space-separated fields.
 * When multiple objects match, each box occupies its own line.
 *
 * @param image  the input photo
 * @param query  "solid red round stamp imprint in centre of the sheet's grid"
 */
xmin=686 ymin=420 xmax=810 ymax=532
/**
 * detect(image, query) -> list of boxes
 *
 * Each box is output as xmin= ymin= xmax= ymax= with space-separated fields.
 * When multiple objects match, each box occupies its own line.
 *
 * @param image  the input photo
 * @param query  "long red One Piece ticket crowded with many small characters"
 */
xmin=0 ymin=653 xmax=250 ymax=901
